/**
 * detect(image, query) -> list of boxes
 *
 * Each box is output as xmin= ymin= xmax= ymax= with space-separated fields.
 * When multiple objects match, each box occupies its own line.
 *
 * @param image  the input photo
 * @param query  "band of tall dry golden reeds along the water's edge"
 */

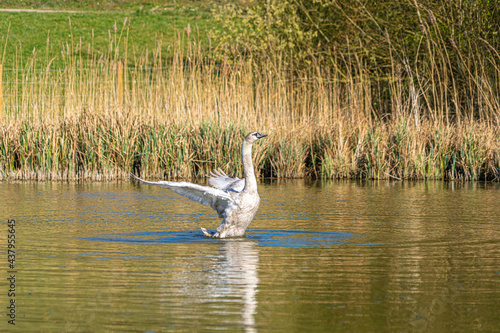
xmin=0 ymin=28 xmax=500 ymax=181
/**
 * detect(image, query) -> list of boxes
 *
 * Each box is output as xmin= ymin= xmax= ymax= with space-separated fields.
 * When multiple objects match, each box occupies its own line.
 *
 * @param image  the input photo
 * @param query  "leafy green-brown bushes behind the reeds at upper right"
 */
xmin=214 ymin=0 xmax=500 ymax=66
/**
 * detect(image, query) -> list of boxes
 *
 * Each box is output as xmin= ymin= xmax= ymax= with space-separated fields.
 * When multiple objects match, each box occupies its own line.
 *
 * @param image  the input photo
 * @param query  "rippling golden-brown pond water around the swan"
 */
xmin=0 ymin=181 xmax=500 ymax=332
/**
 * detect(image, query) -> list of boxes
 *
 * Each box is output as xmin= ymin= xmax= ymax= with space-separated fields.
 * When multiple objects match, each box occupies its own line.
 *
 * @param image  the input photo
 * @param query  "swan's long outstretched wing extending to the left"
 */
xmin=130 ymin=173 xmax=234 ymax=218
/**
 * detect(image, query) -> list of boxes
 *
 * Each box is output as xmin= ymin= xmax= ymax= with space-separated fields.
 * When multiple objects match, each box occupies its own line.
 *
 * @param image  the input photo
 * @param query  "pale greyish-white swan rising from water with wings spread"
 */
xmin=130 ymin=132 xmax=267 ymax=238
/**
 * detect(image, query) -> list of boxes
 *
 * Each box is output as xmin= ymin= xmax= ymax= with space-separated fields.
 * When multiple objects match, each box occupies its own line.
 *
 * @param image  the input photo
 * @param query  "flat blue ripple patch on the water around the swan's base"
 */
xmin=80 ymin=230 xmax=359 ymax=247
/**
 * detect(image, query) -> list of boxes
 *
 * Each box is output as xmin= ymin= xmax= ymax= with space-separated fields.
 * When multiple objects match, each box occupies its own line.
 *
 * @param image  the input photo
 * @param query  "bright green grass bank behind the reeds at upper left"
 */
xmin=0 ymin=1 xmax=222 ymax=68
